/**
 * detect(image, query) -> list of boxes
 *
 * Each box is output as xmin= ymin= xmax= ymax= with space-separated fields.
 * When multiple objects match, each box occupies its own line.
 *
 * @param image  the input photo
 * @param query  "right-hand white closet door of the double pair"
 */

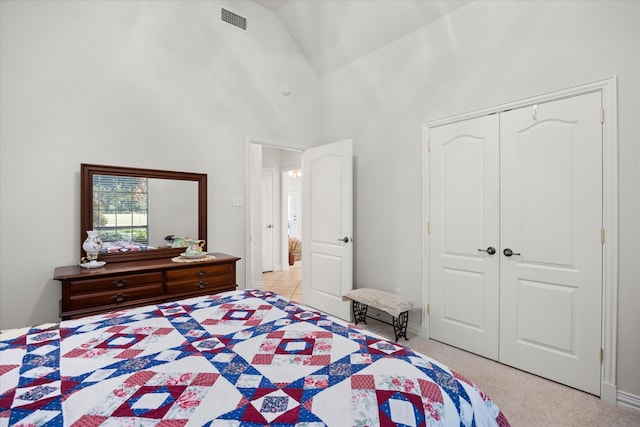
xmin=499 ymin=92 xmax=602 ymax=395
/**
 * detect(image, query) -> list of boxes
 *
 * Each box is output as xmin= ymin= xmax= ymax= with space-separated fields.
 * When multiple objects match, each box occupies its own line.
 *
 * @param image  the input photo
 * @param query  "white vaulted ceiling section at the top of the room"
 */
xmin=254 ymin=0 xmax=472 ymax=76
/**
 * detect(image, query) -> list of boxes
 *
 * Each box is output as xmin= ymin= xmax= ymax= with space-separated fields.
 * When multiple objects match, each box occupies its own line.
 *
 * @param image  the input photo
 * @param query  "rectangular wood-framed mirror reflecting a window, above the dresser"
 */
xmin=80 ymin=163 xmax=207 ymax=262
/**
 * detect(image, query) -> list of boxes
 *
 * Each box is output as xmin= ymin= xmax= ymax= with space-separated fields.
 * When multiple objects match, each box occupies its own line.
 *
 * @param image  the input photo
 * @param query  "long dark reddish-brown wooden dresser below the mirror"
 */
xmin=53 ymin=253 xmax=240 ymax=319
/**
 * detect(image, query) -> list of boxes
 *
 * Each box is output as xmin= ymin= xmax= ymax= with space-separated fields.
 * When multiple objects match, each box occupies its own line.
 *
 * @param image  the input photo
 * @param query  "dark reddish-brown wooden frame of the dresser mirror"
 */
xmin=79 ymin=163 xmax=207 ymax=262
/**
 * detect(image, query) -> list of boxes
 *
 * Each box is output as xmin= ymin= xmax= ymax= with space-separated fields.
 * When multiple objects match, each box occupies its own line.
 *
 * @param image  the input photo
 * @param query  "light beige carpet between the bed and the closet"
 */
xmin=358 ymin=320 xmax=640 ymax=427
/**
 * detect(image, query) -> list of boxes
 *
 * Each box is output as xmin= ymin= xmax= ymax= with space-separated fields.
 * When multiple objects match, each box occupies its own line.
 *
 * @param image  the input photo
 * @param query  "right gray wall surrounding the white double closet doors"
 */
xmin=322 ymin=1 xmax=640 ymax=399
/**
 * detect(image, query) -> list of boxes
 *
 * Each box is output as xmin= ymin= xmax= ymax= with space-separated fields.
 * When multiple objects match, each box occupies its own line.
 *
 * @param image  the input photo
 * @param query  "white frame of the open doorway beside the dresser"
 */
xmin=245 ymin=136 xmax=311 ymax=289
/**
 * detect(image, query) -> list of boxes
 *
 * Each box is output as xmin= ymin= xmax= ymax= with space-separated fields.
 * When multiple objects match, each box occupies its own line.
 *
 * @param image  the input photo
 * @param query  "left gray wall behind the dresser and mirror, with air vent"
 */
xmin=0 ymin=1 xmax=320 ymax=329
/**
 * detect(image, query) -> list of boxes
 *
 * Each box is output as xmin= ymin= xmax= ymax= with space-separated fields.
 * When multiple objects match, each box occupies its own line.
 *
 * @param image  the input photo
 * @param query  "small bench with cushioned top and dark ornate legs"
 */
xmin=342 ymin=288 xmax=418 ymax=341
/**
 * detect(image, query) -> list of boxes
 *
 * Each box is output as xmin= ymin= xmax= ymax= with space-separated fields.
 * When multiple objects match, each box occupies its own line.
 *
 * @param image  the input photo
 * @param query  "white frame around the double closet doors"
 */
xmin=422 ymin=77 xmax=618 ymax=405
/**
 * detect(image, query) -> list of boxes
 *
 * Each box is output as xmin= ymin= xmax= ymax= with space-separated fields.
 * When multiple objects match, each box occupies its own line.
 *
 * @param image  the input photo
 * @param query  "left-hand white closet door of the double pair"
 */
xmin=429 ymin=115 xmax=501 ymax=359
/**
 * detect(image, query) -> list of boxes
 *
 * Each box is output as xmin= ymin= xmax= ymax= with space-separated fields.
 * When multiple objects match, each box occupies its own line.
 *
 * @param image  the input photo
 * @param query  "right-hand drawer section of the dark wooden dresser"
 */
xmin=166 ymin=264 xmax=236 ymax=295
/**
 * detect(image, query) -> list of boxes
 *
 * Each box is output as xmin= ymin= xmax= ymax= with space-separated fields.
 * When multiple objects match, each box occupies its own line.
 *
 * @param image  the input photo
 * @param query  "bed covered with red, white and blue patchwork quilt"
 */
xmin=0 ymin=290 xmax=509 ymax=427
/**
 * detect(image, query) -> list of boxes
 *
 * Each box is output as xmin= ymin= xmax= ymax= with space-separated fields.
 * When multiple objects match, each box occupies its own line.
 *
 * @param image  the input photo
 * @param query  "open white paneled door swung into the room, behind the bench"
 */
xmin=302 ymin=140 xmax=353 ymax=320
